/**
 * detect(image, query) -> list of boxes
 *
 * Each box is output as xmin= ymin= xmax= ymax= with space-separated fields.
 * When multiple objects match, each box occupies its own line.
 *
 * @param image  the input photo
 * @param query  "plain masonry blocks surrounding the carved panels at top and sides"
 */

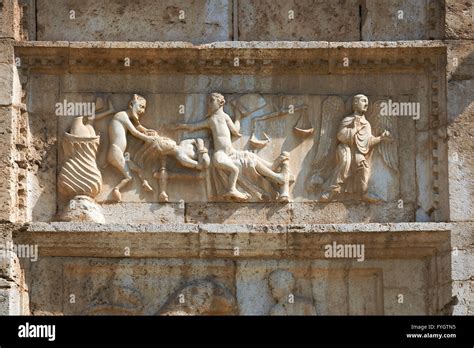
xmin=0 ymin=0 xmax=474 ymax=315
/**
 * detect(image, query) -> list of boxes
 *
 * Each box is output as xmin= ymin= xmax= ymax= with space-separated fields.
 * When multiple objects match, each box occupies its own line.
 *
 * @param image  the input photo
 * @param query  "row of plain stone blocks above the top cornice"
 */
xmin=24 ymin=0 xmax=448 ymax=42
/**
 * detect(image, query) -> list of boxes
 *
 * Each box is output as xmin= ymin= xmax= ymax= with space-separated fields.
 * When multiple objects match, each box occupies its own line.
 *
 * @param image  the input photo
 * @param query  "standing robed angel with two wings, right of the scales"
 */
xmin=309 ymin=94 xmax=398 ymax=203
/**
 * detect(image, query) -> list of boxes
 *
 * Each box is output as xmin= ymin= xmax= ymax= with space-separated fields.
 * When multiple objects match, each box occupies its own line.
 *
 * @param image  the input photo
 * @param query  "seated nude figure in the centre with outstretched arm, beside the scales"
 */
xmin=178 ymin=93 xmax=289 ymax=201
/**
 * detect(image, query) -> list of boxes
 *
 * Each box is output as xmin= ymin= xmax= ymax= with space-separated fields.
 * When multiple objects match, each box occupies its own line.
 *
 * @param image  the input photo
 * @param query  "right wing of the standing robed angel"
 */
xmin=368 ymin=99 xmax=398 ymax=172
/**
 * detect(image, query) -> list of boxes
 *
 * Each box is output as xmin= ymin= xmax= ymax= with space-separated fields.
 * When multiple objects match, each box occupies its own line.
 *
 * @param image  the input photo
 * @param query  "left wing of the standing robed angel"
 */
xmin=309 ymin=96 xmax=344 ymax=188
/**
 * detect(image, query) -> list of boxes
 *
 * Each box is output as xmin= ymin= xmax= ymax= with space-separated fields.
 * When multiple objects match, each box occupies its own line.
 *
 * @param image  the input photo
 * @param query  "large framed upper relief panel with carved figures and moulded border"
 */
xmin=17 ymin=43 xmax=447 ymax=223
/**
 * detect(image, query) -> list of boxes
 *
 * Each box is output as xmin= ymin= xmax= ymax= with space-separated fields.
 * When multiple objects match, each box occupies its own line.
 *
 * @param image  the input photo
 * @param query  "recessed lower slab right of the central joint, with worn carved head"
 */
xmin=237 ymin=261 xmax=390 ymax=315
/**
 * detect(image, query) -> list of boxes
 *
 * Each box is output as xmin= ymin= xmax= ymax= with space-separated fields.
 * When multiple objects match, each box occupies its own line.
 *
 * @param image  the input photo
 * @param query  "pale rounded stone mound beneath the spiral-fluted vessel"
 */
xmin=59 ymin=196 xmax=105 ymax=223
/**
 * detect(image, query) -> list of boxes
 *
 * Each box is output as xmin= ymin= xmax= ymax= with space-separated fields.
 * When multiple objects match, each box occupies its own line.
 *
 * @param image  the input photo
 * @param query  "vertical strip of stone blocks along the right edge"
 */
xmin=446 ymin=36 xmax=474 ymax=315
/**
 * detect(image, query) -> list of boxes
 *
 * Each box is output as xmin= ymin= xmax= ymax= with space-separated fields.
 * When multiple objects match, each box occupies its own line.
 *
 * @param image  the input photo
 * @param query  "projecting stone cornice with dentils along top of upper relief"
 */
xmin=15 ymin=41 xmax=446 ymax=74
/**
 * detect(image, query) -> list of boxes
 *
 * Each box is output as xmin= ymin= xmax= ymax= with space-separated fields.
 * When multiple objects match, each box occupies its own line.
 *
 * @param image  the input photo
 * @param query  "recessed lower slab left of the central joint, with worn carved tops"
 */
xmin=58 ymin=259 xmax=237 ymax=315
